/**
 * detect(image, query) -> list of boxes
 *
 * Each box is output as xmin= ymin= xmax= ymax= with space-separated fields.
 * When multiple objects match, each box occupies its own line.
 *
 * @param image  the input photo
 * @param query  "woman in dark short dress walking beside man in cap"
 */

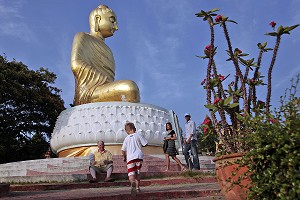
xmin=164 ymin=122 xmax=187 ymax=171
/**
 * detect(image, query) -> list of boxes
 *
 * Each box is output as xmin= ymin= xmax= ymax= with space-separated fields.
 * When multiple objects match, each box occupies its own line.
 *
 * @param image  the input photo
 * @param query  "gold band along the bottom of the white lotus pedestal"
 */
xmin=58 ymin=145 xmax=164 ymax=157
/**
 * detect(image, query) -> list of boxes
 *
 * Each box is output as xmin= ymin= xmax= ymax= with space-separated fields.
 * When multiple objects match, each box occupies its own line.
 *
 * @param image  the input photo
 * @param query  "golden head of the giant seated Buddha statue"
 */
xmin=89 ymin=5 xmax=118 ymax=38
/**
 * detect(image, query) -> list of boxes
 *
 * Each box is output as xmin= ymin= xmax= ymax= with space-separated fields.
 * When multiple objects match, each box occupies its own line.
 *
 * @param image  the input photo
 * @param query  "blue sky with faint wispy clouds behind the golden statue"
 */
xmin=0 ymin=0 xmax=300 ymax=127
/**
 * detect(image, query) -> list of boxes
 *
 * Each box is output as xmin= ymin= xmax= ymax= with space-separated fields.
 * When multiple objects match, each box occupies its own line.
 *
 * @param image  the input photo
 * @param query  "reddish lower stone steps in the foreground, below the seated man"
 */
xmin=1 ymin=177 xmax=224 ymax=200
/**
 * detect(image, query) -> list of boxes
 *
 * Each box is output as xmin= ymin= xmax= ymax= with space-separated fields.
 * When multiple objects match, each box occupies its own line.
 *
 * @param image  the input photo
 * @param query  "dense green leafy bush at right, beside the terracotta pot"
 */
xmin=244 ymin=75 xmax=300 ymax=199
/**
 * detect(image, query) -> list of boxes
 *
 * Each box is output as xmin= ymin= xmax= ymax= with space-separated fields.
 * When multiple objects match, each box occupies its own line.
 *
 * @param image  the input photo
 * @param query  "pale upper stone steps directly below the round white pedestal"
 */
xmin=0 ymin=155 xmax=214 ymax=184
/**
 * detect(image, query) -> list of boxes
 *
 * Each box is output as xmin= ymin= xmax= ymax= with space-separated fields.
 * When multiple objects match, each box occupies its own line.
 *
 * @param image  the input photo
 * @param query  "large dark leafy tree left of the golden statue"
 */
xmin=0 ymin=56 xmax=65 ymax=163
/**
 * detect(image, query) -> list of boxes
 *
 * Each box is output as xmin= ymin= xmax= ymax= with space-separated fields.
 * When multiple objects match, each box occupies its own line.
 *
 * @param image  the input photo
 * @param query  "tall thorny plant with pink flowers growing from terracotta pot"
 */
xmin=196 ymin=9 xmax=299 ymax=152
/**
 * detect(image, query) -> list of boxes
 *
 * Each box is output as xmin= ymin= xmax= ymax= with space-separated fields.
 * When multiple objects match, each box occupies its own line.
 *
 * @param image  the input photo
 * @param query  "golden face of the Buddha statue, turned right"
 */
xmin=99 ymin=12 xmax=118 ymax=38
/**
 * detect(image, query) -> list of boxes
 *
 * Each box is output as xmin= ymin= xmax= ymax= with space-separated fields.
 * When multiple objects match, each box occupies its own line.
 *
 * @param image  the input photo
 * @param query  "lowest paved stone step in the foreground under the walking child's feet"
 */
xmin=1 ymin=183 xmax=222 ymax=200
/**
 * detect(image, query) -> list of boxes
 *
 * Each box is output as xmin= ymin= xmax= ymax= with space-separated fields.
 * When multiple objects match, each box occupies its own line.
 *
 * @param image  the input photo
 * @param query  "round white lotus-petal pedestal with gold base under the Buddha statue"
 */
xmin=50 ymin=102 xmax=181 ymax=157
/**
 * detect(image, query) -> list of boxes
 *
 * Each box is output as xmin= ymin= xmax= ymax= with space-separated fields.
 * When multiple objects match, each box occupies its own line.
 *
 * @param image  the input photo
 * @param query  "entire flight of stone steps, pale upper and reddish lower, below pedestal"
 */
xmin=0 ymin=155 xmax=224 ymax=200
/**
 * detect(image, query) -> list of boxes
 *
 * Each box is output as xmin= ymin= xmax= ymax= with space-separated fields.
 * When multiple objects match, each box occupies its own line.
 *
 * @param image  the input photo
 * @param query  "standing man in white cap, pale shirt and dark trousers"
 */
xmin=183 ymin=113 xmax=200 ymax=170
